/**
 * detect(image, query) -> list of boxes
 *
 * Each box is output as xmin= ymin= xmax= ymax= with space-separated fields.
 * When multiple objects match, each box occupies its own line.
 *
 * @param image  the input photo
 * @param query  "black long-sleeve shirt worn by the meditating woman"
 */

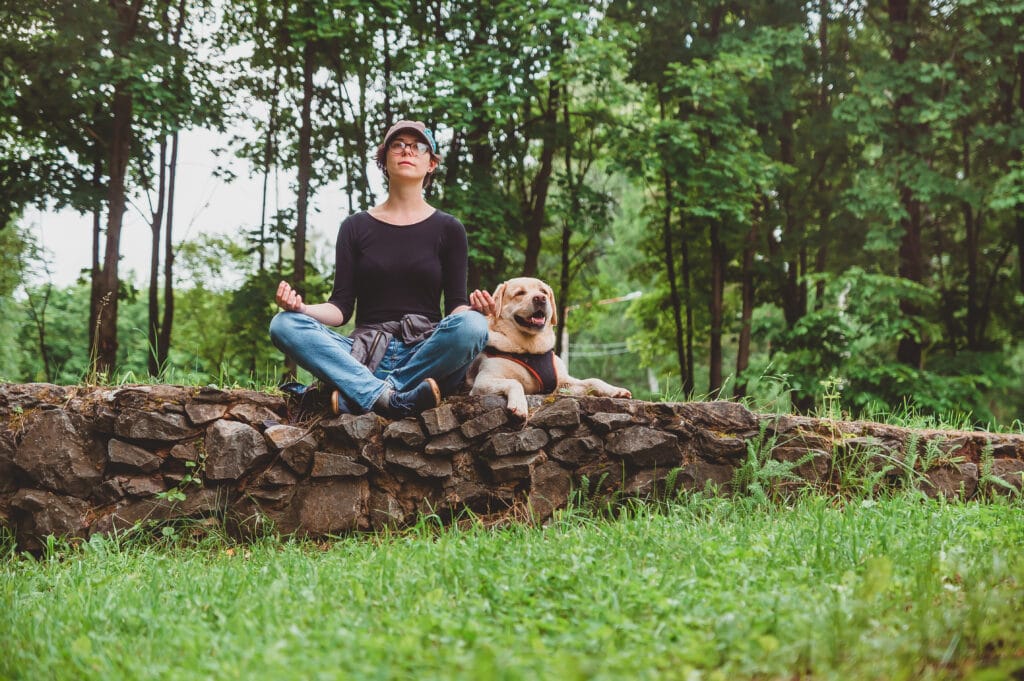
xmin=329 ymin=211 xmax=469 ymax=326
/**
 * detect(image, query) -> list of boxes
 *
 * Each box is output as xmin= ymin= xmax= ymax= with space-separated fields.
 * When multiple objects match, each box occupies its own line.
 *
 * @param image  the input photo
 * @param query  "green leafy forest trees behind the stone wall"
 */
xmin=0 ymin=0 xmax=1024 ymax=427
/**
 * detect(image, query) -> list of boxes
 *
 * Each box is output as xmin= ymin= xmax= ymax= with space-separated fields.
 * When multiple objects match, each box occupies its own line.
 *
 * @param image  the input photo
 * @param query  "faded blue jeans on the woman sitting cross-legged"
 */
xmin=270 ymin=310 xmax=487 ymax=412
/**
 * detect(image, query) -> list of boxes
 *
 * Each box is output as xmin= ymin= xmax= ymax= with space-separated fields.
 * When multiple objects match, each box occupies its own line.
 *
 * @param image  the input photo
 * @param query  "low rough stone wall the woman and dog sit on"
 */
xmin=0 ymin=384 xmax=1024 ymax=550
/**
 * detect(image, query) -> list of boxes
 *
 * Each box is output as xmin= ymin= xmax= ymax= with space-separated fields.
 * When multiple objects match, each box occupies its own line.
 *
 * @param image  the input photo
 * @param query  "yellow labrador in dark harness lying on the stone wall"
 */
xmin=467 ymin=276 xmax=632 ymax=418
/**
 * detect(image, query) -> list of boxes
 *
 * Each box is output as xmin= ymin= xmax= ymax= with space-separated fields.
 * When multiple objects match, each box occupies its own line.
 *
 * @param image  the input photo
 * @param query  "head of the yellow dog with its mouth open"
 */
xmin=492 ymin=276 xmax=558 ymax=352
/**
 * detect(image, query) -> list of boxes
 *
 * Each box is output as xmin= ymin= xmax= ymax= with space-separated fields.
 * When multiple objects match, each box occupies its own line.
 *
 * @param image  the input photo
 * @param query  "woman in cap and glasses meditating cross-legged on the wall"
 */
xmin=270 ymin=121 xmax=494 ymax=419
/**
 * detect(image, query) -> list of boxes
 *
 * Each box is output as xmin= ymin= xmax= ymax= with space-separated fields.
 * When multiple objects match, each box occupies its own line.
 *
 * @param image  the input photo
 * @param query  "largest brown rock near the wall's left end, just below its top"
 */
xmin=13 ymin=410 xmax=105 ymax=499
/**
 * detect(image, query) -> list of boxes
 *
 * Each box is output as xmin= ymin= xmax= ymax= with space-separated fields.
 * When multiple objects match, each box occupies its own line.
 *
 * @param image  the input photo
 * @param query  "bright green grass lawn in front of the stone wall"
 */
xmin=0 ymin=495 xmax=1024 ymax=680
